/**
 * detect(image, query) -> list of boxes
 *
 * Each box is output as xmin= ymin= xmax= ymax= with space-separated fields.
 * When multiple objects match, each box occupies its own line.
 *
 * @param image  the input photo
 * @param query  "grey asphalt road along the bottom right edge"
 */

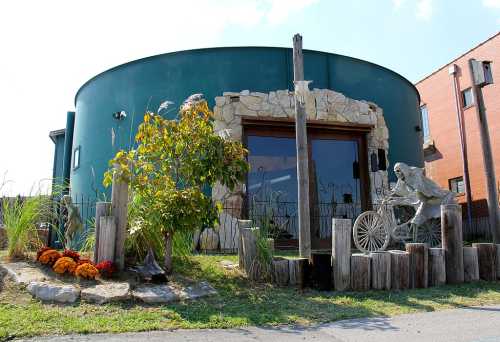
xmin=15 ymin=305 xmax=500 ymax=342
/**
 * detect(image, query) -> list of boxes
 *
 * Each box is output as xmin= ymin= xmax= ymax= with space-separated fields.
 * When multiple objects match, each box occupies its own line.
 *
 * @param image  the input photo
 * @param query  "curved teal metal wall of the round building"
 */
xmin=71 ymin=48 xmax=423 ymax=198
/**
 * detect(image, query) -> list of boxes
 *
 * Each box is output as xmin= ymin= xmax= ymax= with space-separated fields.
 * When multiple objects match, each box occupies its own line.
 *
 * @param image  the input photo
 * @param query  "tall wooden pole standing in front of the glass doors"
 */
xmin=293 ymin=34 xmax=311 ymax=259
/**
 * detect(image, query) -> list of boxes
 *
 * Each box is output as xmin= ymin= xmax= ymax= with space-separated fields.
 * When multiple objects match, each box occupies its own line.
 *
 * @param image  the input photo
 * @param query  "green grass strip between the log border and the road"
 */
xmin=0 ymin=252 xmax=500 ymax=341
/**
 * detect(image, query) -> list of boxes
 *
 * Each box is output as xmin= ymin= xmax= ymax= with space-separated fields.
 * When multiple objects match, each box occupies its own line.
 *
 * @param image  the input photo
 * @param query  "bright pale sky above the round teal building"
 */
xmin=0 ymin=0 xmax=500 ymax=195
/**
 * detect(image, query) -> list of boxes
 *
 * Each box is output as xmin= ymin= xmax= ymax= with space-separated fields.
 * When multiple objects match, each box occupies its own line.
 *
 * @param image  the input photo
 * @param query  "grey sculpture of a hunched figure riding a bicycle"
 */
xmin=353 ymin=163 xmax=457 ymax=253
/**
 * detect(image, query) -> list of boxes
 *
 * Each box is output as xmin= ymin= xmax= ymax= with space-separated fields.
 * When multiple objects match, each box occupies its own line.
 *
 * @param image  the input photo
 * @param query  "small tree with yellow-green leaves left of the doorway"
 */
xmin=104 ymin=96 xmax=249 ymax=273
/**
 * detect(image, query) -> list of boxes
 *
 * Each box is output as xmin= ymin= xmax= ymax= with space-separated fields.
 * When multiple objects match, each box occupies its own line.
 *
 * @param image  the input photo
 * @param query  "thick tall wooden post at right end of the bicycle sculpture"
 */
xmin=441 ymin=204 xmax=464 ymax=284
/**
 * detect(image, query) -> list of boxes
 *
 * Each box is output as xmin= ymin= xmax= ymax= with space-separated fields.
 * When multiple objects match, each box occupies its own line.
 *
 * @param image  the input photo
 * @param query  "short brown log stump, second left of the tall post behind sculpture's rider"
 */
xmin=406 ymin=243 xmax=429 ymax=289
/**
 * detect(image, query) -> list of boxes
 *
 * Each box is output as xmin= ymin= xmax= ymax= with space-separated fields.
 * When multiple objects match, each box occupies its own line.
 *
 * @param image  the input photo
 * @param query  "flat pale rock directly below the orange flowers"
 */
xmin=27 ymin=281 xmax=80 ymax=303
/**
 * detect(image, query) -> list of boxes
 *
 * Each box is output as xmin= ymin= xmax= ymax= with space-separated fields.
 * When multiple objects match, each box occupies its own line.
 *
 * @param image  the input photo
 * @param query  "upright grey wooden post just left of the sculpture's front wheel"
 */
xmin=332 ymin=218 xmax=352 ymax=291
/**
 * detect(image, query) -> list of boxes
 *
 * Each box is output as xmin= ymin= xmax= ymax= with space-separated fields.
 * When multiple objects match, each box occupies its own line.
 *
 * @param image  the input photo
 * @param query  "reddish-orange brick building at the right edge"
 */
xmin=416 ymin=32 xmax=500 ymax=217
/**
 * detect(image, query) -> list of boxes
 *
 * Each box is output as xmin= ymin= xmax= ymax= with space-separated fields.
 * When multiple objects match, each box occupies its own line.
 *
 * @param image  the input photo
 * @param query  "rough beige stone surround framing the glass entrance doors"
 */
xmin=212 ymin=89 xmax=389 ymax=249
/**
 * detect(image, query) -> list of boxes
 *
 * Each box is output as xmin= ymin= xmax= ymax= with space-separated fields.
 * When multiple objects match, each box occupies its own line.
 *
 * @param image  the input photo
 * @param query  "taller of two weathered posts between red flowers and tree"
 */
xmin=111 ymin=168 xmax=128 ymax=271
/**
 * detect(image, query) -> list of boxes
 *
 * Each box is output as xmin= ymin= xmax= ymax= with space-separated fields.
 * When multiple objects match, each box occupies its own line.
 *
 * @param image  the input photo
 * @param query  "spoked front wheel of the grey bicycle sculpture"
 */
xmin=352 ymin=211 xmax=390 ymax=253
